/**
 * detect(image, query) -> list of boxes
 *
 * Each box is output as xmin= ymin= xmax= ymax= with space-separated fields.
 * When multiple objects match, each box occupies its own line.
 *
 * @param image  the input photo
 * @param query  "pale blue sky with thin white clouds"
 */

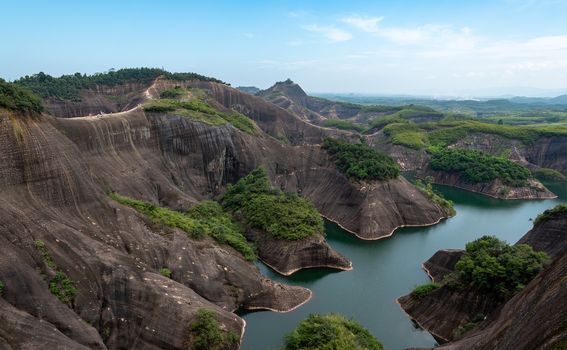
xmin=0 ymin=0 xmax=567 ymax=96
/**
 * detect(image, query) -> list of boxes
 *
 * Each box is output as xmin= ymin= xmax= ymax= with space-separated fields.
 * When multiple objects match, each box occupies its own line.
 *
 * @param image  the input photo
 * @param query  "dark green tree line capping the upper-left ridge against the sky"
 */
xmin=14 ymin=68 xmax=222 ymax=101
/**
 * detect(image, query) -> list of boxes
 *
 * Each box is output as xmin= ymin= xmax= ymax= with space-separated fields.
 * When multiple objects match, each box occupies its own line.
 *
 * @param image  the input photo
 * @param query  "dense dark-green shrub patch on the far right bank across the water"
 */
xmin=429 ymin=148 xmax=531 ymax=187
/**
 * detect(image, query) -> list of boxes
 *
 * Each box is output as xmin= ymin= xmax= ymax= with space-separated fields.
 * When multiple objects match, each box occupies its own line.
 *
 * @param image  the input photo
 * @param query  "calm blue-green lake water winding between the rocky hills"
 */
xmin=241 ymin=183 xmax=567 ymax=350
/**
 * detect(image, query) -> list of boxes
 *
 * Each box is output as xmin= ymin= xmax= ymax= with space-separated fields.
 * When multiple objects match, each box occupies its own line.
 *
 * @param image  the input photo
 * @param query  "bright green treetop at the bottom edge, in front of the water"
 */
xmin=283 ymin=314 xmax=383 ymax=350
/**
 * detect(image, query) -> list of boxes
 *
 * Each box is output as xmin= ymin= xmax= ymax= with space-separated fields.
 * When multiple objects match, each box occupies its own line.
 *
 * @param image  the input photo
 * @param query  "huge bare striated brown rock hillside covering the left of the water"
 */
xmin=0 ymin=78 xmax=458 ymax=349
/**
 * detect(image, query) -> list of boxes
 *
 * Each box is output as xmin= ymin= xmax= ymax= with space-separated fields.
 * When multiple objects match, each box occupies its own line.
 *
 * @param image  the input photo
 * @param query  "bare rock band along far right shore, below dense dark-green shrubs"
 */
xmin=417 ymin=167 xmax=557 ymax=199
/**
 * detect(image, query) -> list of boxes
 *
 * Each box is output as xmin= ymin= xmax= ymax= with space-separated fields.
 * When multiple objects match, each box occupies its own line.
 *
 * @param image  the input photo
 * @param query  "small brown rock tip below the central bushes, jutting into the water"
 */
xmin=246 ymin=229 xmax=352 ymax=276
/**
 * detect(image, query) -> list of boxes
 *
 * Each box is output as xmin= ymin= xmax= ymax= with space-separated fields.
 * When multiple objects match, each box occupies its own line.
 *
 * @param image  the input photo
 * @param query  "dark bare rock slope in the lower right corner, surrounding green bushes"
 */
xmin=398 ymin=214 xmax=567 ymax=349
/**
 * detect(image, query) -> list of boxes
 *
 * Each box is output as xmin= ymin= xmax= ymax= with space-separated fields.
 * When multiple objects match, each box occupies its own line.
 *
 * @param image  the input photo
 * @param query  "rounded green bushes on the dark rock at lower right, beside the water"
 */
xmin=447 ymin=236 xmax=549 ymax=298
